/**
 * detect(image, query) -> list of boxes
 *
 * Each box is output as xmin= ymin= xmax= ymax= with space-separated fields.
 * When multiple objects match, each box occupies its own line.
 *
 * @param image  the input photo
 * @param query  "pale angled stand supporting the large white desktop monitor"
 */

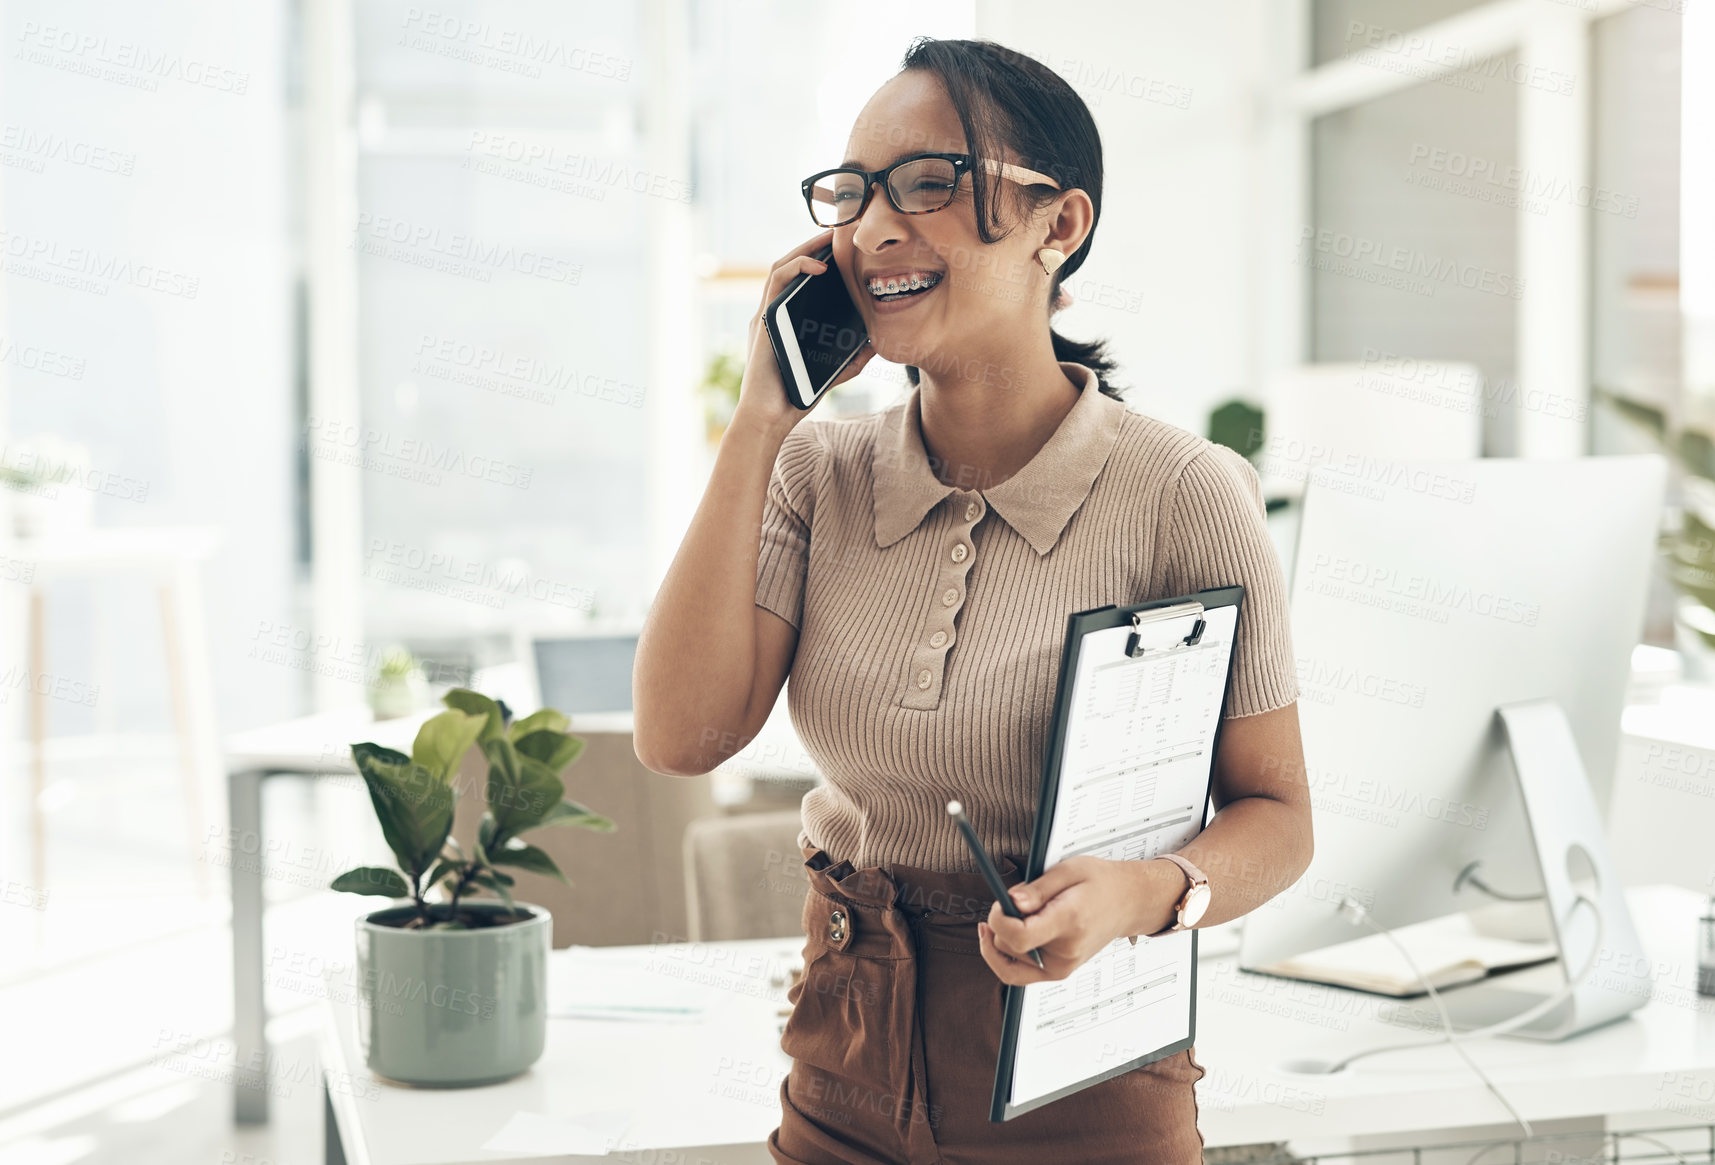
xmin=1441 ymin=700 xmax=1652 ymax=1040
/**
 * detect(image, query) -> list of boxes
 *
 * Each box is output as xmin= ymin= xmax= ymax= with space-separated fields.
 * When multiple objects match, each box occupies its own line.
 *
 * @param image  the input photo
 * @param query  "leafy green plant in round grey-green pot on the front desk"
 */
xmin=333 ymin=688 xmax=614 ymax=1086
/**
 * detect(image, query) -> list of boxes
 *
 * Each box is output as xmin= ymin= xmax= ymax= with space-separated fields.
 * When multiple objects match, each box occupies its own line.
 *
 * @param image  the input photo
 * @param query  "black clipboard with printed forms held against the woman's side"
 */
xmin=990 ymin=585 xmax=1245 ymax=1120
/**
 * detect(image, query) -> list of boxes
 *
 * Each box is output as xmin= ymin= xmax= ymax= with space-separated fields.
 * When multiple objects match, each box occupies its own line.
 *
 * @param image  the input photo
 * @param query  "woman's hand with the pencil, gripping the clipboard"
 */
xmin=976 ymin=858 xmax=1156 ymax=985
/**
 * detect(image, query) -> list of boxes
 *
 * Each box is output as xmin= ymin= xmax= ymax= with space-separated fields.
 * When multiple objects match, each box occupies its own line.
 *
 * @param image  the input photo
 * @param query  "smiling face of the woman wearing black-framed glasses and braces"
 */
xmin=833 ymin=70 xmax=1087 ymax=376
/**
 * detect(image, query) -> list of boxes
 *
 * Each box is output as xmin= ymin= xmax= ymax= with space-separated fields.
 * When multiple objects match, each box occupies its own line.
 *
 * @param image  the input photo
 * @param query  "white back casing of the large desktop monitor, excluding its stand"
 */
xmin=1238 ymin=456 xmax=1665 ymax=1002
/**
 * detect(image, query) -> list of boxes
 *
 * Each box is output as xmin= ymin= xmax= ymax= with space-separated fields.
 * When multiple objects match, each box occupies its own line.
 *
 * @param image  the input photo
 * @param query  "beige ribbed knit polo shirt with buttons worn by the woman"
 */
xmin=756 ymin=362 xmax=1298 ymax=870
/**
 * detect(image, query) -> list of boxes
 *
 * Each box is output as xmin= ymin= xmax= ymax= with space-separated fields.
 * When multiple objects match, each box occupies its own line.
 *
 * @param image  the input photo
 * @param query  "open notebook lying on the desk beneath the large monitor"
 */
xmin=1255 ymin=914 xmax=1561 ymax=999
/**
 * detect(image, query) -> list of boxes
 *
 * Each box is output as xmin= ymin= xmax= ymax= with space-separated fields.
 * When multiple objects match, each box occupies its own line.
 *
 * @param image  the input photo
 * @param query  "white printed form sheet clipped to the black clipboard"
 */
xmin=1010 ymin=604 xmax=1238 ymax=1105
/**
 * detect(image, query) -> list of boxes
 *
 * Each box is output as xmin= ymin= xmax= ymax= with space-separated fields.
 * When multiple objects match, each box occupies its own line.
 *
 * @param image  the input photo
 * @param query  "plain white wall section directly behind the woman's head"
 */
xmin=978 ymin=0 xmax=1271 ymax=434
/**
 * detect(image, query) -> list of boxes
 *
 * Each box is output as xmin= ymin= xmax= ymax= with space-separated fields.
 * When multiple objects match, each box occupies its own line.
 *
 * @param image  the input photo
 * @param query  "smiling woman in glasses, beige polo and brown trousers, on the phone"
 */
xmin=635 ymin=39 xmax=1312 ymax=1165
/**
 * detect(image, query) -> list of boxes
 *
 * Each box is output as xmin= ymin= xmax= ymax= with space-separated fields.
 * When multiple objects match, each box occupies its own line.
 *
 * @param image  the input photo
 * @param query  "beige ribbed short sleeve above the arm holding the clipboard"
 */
xmin=1163 ymin=444 xmax=1298 ymax=719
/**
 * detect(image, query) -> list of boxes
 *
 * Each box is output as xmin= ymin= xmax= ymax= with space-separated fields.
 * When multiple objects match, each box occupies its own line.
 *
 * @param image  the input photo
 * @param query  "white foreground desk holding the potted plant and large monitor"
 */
xmin=322 ymin=887 xmax=1715 ymax=1165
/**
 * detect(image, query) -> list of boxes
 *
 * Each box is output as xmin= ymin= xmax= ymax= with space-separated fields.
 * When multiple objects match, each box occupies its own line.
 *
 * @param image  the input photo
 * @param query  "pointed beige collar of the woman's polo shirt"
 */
xmin=871 ymin=360 xmax=1127 ymax=554
